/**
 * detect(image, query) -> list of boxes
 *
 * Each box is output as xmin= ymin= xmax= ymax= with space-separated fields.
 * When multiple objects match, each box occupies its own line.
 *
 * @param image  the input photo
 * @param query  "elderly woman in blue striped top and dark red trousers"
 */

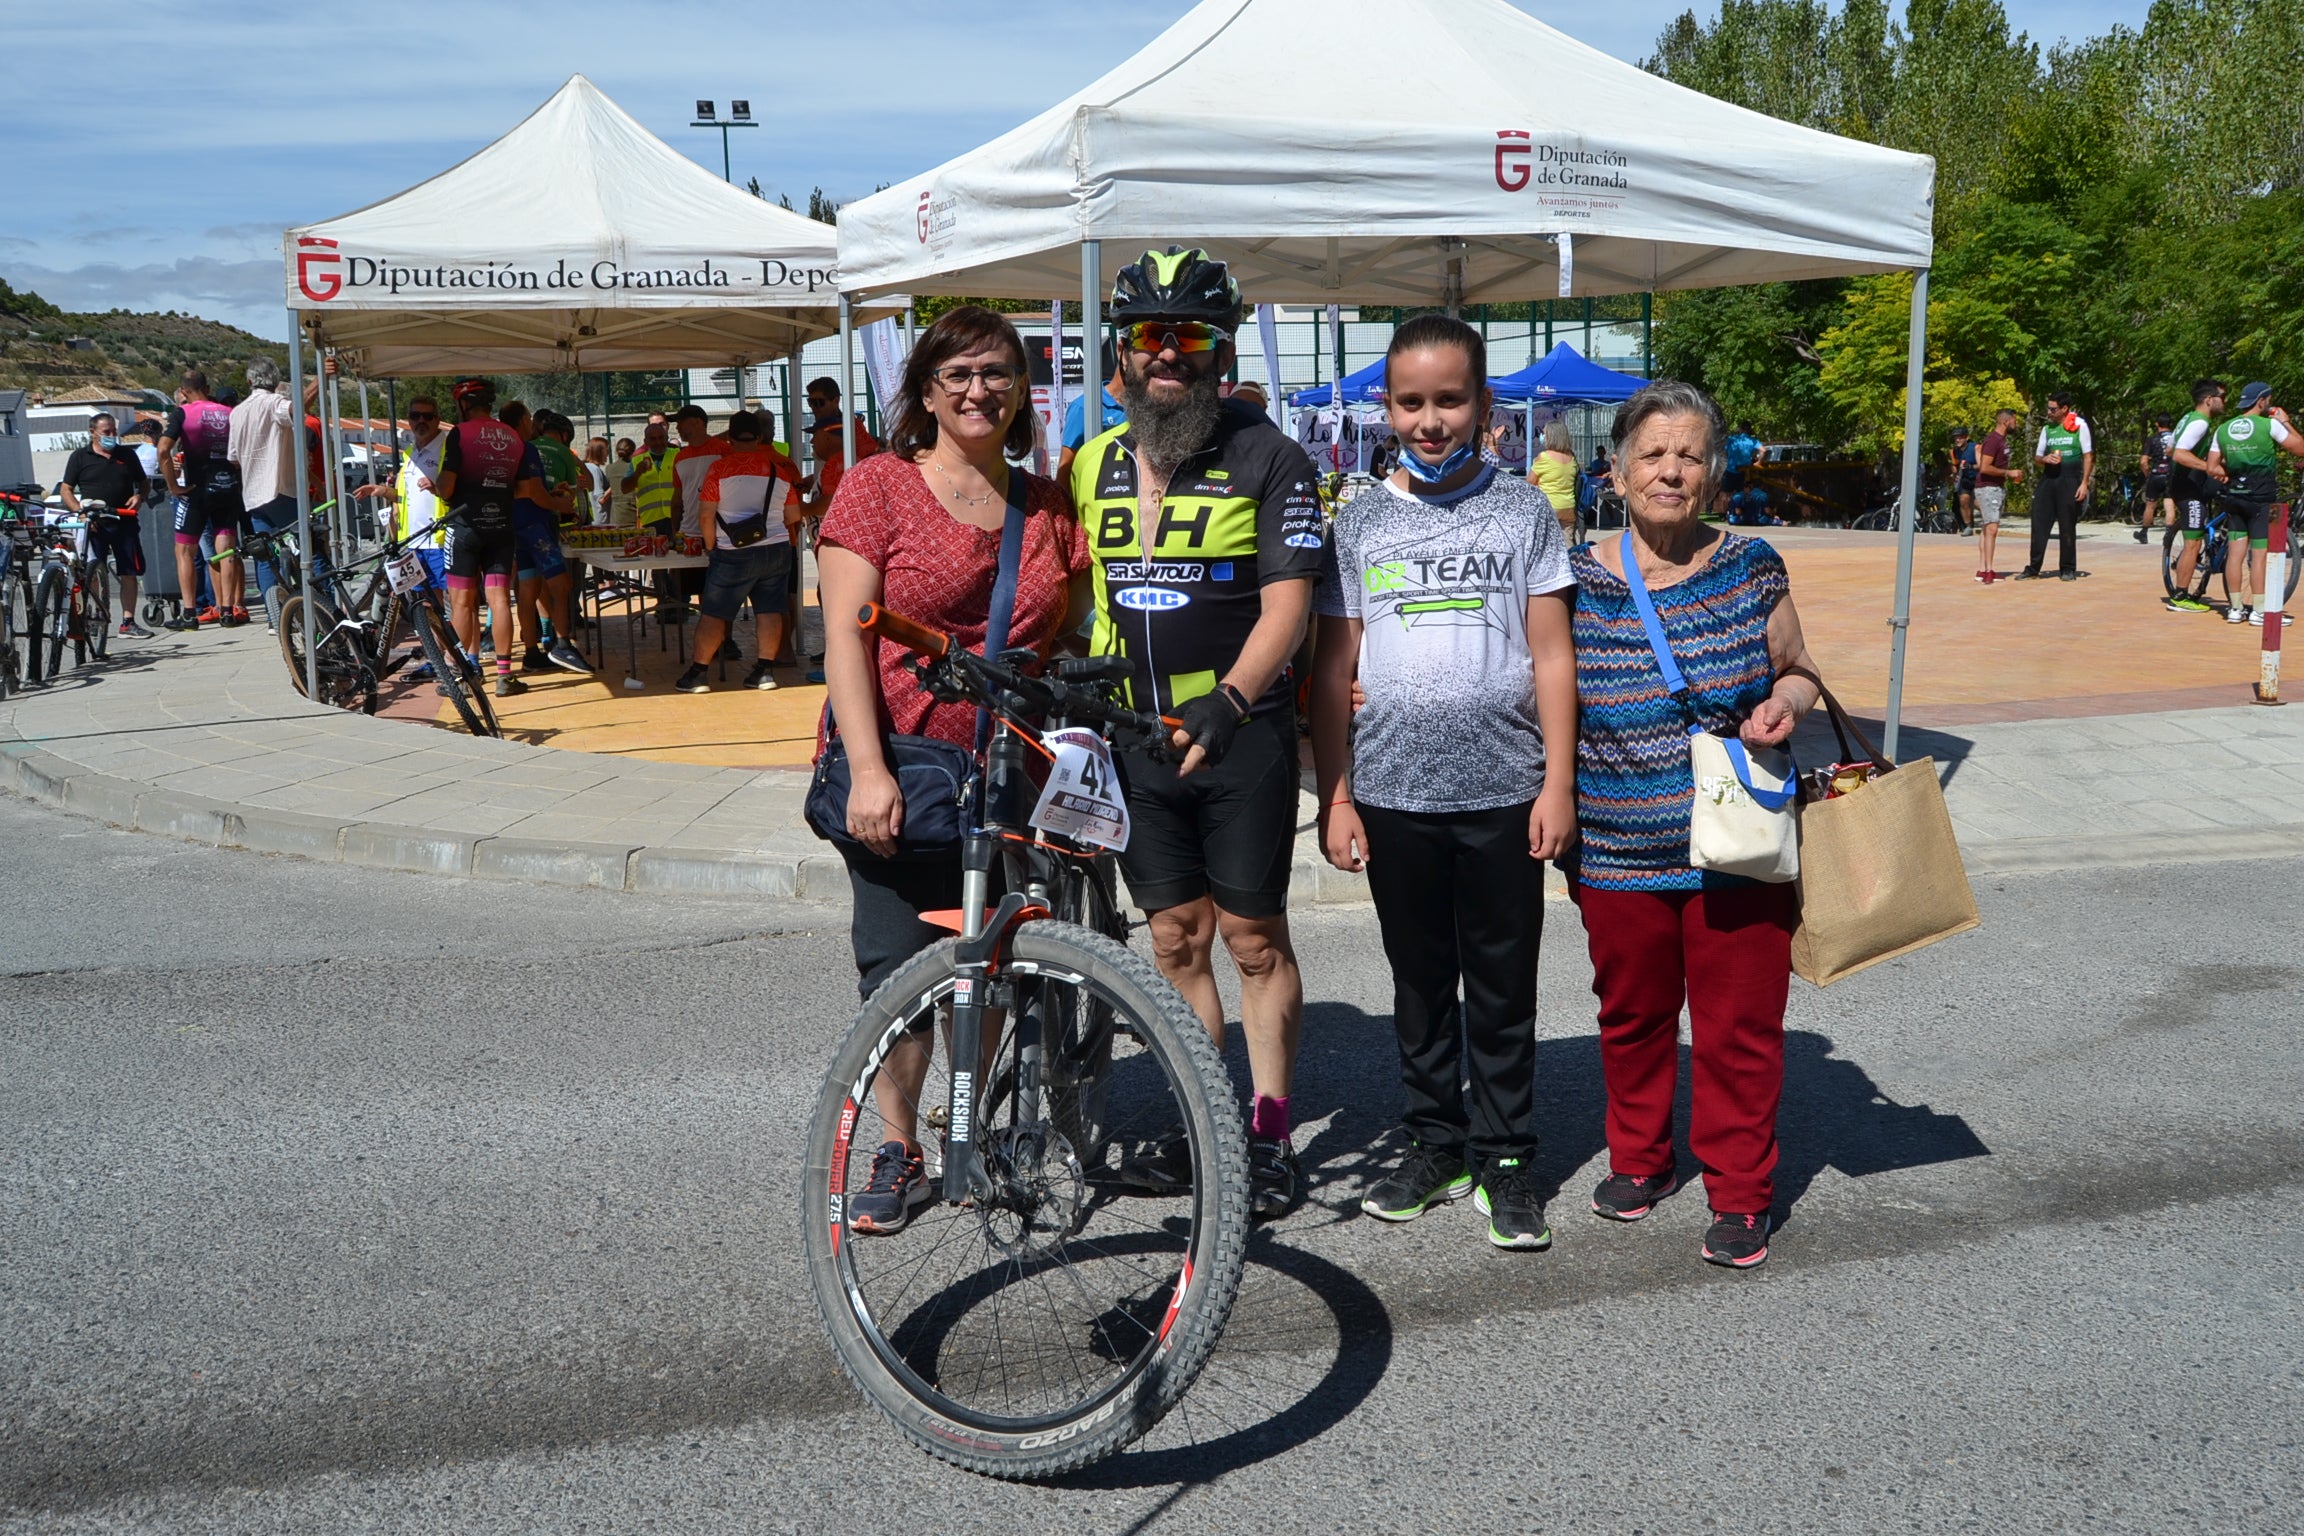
xmin=1571 ymin=380 xmax=1820 ymax=1269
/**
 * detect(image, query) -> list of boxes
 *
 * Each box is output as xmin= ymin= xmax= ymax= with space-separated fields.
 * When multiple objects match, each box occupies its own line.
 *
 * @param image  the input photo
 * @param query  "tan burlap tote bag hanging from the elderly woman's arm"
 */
xmin=1793 ymin=693 xmax=1981 ymax=986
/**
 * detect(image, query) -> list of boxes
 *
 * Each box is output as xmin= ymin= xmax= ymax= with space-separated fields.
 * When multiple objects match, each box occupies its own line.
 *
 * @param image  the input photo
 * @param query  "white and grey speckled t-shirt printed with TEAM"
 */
xmin=1313 ymin=467 xmax=1576 ymax=813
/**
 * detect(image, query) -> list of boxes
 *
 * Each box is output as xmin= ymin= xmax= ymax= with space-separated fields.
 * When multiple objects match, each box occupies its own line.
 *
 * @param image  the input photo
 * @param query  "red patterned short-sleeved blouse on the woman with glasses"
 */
xmin=820 ymin=454 xmax=1087 ymax=746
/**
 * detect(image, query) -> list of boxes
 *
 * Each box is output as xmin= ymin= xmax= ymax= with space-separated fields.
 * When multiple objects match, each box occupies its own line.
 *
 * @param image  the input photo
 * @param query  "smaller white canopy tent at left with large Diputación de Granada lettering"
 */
xmin=281 ymin=74 xmax=850 ymax=691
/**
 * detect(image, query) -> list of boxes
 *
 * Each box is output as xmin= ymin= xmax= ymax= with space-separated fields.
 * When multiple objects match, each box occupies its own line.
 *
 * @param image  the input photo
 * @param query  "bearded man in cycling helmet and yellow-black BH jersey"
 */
xmin=1071 ymin=246 xmax=1325 ymax=1218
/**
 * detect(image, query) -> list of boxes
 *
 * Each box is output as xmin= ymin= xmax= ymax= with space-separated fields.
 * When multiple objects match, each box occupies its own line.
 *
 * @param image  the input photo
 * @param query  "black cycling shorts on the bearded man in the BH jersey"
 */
xmin=1120 ymin=709 xmax=1297 ymax=917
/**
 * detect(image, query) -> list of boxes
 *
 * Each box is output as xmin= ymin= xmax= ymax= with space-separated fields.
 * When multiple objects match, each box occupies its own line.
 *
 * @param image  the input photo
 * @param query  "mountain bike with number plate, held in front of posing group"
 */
xmin=802 ymin=606 xmax=1249 ymax=1478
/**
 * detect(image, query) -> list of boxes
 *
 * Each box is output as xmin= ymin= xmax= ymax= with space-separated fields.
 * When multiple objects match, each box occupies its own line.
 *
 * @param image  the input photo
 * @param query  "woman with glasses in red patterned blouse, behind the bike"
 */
xmin=816 ymin=304 xmax=1090 ymax=1232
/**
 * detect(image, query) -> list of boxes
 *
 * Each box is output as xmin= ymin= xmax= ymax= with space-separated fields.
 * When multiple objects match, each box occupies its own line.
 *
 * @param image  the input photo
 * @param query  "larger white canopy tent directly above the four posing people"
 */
xmin=839 ymin=0 xmax=1935 ymax=751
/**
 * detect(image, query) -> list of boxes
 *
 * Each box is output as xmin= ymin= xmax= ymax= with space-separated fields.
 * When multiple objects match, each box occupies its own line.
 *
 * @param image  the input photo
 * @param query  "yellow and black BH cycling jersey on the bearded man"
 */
xmin=1071 ymin=401 xmax=1327 ymax=714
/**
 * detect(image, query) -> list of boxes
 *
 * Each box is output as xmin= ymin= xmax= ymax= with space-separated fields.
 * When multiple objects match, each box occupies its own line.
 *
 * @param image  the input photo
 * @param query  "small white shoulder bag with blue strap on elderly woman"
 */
xmin=1617 ymin=530 xmax=1799 ymax=884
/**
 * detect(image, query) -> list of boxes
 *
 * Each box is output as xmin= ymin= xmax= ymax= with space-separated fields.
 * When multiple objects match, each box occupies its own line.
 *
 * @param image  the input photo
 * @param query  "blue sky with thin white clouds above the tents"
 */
xmin=0 ymin=0 xmax=2150 ymax=336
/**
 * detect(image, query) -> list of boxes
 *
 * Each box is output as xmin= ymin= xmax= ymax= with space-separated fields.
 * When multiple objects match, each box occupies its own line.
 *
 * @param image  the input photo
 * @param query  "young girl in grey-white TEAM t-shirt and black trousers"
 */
xmin=1311 ymin=315 xmax=1576 ymax=1248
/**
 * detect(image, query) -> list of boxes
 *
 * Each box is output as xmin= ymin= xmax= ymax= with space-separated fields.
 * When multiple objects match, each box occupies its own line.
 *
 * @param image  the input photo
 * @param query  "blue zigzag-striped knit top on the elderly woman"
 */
xmin=1569 ymin=532 xmax=1790 ymax=891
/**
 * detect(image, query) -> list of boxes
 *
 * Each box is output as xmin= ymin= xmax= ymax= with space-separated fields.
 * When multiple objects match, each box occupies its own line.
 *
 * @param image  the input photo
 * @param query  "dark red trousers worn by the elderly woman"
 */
xmin=1576 ymin=884 xmax=1799 ymax=1216
